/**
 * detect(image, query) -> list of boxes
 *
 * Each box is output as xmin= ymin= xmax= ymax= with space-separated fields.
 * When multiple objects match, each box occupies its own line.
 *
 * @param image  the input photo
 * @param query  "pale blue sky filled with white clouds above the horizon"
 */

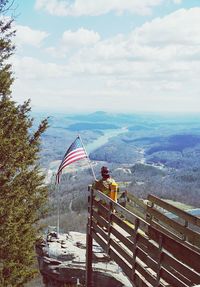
xmin=7 ymin=0 xmax=200 ymax=113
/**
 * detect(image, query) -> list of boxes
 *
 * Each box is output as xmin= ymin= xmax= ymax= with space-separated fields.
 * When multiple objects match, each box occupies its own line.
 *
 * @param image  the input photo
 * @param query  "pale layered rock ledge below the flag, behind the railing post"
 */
xmin=36 ymin=232 xmax=132 ymax=287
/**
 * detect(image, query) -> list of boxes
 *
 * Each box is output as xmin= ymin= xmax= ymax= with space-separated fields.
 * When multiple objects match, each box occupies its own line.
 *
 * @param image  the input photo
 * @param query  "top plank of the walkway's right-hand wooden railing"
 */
xmin=148 ymin=194 xmax=200 ymax=227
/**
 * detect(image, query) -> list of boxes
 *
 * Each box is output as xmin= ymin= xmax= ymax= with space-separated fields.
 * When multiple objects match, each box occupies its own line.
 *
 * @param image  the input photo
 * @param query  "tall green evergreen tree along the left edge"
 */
xmin=0 ymin=0 xmax=47 ymax=287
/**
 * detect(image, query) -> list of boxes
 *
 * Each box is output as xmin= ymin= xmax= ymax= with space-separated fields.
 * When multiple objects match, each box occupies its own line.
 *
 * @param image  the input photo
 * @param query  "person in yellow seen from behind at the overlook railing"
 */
xmin=92 ymin=166 xmax=118 ymax=201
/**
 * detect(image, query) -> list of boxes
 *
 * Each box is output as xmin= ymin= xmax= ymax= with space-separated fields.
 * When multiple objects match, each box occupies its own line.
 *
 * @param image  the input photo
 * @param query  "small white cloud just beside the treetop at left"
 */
xmin=15 ymin=25 xmax=48 ymax=47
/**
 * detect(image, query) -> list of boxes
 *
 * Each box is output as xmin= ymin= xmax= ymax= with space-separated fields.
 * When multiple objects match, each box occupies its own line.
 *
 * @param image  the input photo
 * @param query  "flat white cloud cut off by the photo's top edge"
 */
xmin=35 ymin=0 xmax=163 ymax=16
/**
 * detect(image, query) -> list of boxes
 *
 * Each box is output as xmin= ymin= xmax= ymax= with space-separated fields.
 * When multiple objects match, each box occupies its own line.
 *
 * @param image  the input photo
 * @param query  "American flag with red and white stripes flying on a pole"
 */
xmin=56 ymin=136 xmax=87 ymax=183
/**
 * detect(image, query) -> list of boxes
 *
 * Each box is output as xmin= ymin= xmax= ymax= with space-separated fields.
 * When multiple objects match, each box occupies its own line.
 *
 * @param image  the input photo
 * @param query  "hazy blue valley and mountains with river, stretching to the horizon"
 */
xmin=33 ymin=111 xmax=200 ymax=207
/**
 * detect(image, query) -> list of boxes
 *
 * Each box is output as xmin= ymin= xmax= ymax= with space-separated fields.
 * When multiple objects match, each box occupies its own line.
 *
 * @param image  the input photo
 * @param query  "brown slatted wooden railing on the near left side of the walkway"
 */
xmin=86 ymin=189 xmax=200 ymax=287
